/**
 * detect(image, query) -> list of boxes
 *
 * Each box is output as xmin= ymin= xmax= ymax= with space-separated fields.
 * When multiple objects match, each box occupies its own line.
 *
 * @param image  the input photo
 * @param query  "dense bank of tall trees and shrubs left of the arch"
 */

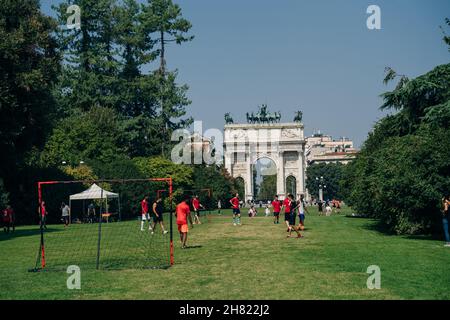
xmin=0 ymin=0 xmax=234 ymax=223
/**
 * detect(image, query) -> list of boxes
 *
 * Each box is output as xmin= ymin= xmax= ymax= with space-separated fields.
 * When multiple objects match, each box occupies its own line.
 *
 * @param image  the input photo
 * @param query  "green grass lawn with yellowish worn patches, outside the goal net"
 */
xmin=0 ymin=209 xmax=450 ymax=299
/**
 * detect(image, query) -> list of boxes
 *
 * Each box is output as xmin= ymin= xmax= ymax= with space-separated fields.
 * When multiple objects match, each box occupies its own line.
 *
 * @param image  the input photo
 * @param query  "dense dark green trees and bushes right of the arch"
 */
xmin=341 ymin=20 xmax=450 ymax=234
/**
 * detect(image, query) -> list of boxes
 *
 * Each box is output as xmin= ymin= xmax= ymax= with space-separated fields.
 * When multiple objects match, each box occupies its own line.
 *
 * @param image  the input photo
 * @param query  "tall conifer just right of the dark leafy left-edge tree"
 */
xmin=55 ymin=0 xmax=120 ymax=111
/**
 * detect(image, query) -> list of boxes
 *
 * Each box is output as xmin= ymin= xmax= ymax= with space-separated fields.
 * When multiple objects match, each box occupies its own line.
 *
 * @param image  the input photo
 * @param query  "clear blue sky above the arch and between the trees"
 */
xmin=41 ymin=0 xmax=450 ymax=146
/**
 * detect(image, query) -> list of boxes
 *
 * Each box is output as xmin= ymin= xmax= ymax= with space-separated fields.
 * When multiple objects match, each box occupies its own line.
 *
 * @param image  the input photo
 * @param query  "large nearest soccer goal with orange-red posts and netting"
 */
xmin=30 ymin=178 xmax=174 ymax=271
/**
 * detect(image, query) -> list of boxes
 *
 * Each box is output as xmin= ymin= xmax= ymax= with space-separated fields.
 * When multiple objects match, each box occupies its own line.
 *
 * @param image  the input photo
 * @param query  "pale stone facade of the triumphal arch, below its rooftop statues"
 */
xmin=224 ymin=123 xmax=306 ymax=200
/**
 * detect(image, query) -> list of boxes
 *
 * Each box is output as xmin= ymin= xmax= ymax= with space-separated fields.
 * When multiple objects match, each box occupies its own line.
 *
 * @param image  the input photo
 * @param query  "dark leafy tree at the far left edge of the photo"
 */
xmin=0 ymin=0 xmax=60 ymax=182
